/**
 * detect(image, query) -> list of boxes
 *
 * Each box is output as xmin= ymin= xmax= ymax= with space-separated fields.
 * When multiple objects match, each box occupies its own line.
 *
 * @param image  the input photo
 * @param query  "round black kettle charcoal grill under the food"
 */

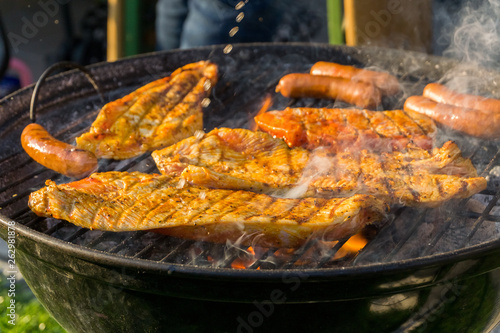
xmin=0 ymin=44 xmax=500 ymax=332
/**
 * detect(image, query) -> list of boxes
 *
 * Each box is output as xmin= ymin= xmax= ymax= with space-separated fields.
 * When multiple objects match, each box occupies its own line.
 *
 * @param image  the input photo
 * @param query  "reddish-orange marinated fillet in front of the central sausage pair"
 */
xmin=254 ymin=108 xmax=436 ymax=153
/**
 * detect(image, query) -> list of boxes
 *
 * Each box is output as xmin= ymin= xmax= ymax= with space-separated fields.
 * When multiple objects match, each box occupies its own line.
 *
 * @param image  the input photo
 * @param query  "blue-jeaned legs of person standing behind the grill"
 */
xmin=156 ymin=0 xmax=281 ymax=50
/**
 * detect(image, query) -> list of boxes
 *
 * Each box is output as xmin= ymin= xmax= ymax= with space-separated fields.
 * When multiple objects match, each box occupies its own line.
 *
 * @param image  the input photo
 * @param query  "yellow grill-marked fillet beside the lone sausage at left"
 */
xmin=76 ymin=61 xmax=217 ymax=159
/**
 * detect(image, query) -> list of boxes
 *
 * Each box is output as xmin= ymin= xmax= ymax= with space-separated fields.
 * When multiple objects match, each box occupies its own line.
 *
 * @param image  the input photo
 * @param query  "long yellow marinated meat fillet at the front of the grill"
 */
xmin=29 ymin=172 xmax=387 ymax=247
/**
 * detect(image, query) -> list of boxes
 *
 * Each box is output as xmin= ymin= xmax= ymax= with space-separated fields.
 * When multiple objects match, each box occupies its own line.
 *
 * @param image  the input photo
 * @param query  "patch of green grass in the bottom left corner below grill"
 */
xmin=0 ymin=272 xmax=66 ymax=333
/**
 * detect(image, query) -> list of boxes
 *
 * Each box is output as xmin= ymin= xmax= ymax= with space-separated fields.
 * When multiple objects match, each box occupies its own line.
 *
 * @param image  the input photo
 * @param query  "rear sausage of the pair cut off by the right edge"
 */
xmin=423 ymin=83 xmax=500 ymax=112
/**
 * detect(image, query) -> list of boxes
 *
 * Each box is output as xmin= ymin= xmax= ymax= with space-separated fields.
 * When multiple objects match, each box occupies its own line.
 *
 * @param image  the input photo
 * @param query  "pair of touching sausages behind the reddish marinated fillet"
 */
xmin=276 ymin=61 xmax=400 ymax=108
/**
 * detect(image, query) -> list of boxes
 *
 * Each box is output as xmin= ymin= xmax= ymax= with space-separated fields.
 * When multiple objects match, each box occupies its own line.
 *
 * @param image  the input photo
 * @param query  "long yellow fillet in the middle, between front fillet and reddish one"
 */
xmin=152 ymin=128 xmax=486 ymax=207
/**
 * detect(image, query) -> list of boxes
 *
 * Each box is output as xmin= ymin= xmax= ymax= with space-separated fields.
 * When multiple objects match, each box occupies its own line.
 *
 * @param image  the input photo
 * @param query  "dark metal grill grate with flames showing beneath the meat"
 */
xmin=0 ymin=44 xmax=500 ymax=270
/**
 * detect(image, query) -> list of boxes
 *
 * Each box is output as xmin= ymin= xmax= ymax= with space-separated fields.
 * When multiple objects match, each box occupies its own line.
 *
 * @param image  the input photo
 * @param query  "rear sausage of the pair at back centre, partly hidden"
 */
xmin=310 ymin=61 xmax=400 ymax=95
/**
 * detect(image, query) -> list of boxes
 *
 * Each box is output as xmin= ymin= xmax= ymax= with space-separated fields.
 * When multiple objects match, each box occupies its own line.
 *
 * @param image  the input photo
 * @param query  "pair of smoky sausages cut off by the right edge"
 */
xmin=404 ymin=83 xmax=500 ymax=139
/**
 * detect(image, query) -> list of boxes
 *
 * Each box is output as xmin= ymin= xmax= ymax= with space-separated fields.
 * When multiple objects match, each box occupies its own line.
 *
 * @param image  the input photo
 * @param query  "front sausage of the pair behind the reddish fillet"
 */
xmin=276 ymin=73 xmax=382 ymax=108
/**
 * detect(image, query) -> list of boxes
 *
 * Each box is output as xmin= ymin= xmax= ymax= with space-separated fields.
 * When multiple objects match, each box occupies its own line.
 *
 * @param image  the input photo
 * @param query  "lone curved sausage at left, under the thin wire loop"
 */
xmin=21 ymin=123 xmax=98 ymax=178
